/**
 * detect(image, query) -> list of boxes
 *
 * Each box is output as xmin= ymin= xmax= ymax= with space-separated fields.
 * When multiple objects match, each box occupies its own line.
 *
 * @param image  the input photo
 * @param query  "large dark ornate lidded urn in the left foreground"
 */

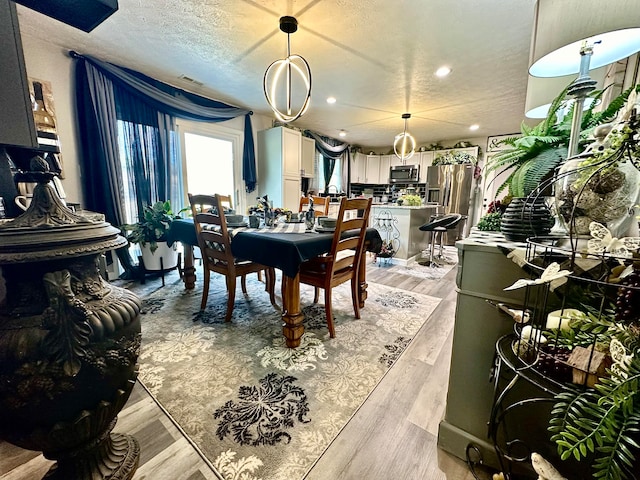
xmin=0 ymin=157 xmax=141 ymax=480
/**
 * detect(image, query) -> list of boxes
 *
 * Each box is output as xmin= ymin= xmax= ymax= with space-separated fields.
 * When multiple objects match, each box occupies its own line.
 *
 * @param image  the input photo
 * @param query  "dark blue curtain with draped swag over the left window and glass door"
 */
xmin=70 ymin=52 xmax=256 ymax=271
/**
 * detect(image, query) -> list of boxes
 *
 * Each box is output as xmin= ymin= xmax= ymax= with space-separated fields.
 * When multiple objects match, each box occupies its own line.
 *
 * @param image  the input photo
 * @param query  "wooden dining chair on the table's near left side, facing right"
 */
xmin=189 ymin=194 xmax=277 ymax=322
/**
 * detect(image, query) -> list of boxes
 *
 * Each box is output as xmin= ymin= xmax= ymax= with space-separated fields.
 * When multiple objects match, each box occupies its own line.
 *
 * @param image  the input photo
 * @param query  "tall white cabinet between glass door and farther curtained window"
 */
xmin=258 ymin=127 xmax=302 ymax=211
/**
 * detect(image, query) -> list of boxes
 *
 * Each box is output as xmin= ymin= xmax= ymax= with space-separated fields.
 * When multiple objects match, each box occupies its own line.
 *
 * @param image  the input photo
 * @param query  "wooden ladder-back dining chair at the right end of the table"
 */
xmin=300 ymin=197 xmax=371 ymax=338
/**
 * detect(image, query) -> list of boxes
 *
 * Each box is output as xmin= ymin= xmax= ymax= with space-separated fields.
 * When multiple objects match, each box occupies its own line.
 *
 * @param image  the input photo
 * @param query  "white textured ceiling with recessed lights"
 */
xmin=18 ymin=0 xmax=535 ymax=148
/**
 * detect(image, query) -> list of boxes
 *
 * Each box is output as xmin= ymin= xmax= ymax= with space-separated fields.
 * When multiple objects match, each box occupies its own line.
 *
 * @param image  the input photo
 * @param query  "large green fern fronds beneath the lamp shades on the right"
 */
xmin=485 ymin=86 xmax=635 ymax=197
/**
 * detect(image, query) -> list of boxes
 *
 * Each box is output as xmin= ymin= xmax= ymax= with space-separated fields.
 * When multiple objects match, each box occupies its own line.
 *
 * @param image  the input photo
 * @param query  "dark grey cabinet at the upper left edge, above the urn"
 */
xmin=0 ymin=0 xmax=38 ymax=148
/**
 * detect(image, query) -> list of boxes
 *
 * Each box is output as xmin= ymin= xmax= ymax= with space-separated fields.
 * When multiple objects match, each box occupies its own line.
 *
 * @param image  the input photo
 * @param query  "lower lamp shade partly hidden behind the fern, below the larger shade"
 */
xmin=524 ymin=67 xmax=607 ymax=118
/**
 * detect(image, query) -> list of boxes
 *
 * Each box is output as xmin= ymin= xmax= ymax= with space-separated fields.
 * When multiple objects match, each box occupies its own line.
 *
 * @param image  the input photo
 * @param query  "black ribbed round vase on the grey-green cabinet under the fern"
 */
xmin=500 ymin=197 xmax=554 ymax=242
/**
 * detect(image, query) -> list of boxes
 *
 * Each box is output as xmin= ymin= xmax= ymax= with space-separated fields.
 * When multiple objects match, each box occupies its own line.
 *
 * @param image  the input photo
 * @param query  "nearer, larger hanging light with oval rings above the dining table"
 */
xmin=263 ymin=17 xmax=311 ymax=123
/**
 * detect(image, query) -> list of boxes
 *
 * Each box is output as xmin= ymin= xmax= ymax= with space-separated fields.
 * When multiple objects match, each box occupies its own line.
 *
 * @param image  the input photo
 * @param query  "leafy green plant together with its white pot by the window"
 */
xmin=122 ymin=200 xmax=182 ymax=271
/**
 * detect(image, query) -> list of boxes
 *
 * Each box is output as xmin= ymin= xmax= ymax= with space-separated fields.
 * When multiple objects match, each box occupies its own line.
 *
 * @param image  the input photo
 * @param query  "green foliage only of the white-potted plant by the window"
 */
xmin=121 ymin=200 xmax=182 ymax=253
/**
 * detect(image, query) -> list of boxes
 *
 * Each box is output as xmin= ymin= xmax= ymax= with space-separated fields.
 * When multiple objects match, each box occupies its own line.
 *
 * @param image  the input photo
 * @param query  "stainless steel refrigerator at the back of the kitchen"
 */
xmin=427 ymin=164 xmax=474 ymax=245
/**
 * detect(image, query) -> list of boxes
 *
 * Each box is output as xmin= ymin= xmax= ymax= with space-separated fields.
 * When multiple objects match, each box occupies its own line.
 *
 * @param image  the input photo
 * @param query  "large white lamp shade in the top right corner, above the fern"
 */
xmin=529 ymin=0 xmax=640 ymax=77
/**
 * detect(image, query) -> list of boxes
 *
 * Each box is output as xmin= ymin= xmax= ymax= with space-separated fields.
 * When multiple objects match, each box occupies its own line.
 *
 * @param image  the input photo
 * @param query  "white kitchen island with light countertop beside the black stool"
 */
xmin=369 ymin=204 xmax=443 ymax=265
